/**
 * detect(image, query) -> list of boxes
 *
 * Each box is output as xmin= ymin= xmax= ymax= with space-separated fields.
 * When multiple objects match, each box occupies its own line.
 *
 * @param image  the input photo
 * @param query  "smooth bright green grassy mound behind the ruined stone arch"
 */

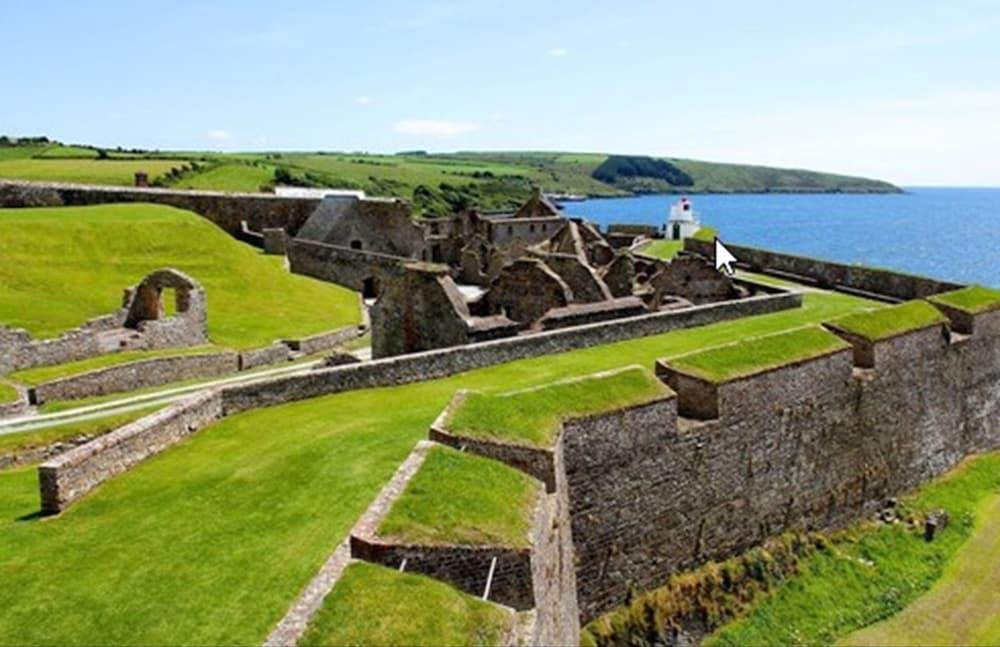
xmin=0 ymin=204 xmax=360 ymax=348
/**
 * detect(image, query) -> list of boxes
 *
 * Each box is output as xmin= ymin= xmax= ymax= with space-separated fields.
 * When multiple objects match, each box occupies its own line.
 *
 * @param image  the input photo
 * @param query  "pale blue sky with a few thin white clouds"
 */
xmin=0 ymin=0 xmax=1000 ymax=186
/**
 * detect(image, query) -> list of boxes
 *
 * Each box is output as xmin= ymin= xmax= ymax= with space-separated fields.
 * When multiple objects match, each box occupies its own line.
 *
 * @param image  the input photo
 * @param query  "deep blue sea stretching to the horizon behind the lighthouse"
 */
xmin=564 ymin=187 xmax=1000 ymax=287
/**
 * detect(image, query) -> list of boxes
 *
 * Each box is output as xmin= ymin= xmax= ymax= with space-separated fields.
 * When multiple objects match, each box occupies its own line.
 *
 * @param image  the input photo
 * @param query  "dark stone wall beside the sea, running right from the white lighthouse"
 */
xmin=684 ymin=238 xmax=962 ymax=301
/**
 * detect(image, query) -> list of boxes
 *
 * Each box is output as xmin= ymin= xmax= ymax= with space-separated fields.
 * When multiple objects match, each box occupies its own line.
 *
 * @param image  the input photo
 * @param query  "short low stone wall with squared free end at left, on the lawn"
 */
xmin=38 ymin=391 xmax=222 ymax=514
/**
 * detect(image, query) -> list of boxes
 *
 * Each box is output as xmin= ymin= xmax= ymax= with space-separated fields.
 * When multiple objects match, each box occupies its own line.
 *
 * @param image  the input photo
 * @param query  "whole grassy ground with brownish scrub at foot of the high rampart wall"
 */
xmin=584 ymin=452 xmax=1000 ymax=646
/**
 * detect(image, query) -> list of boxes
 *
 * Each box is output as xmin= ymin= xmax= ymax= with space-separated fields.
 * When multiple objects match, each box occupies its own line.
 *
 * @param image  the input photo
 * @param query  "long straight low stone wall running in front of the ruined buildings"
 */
xmin=223 ymin=293 xmax=802 ymax=415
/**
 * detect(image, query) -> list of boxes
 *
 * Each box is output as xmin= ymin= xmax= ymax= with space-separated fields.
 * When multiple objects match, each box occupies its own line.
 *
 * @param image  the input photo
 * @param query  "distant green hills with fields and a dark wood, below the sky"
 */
xmin=0 ymin=138 xmax=899 ymax=214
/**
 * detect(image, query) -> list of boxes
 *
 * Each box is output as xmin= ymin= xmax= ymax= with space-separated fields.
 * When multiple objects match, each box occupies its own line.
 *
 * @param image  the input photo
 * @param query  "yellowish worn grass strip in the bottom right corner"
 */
xmin=843 ymin=492 xmax=1000 ymax=647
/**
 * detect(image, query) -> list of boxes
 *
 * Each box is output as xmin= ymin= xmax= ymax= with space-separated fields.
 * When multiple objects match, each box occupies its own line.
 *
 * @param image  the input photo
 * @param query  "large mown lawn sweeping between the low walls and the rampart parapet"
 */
xmin=0 ymin=293 xmax=873 ymax=645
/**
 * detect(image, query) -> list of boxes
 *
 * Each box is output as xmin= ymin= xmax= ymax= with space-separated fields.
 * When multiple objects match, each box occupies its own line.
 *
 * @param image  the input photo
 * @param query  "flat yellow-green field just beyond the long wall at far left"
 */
xmin=0 ymin=159 xmax=184 ymax=186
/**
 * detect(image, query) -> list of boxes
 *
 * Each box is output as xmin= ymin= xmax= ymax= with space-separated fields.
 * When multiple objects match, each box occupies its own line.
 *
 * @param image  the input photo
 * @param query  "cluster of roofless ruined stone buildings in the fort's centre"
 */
xmin=288 ymin=189 xmax=745 ymax=357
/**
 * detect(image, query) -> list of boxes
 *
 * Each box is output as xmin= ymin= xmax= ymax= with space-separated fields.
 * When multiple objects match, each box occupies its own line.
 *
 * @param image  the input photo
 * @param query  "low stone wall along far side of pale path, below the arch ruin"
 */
xmin=31 ymin=351 xmax=240 ymax=404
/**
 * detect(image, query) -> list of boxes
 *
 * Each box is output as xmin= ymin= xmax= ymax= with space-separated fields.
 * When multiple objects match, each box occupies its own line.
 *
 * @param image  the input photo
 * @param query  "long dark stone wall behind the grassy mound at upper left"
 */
xmin=0 ymin=180 xmax=321 ymax=238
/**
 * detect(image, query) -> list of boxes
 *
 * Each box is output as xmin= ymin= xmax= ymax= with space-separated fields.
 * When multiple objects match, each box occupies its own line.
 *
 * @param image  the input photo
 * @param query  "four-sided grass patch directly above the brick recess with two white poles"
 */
xmin=377 ymin=446 xmax=539 ymax=548
